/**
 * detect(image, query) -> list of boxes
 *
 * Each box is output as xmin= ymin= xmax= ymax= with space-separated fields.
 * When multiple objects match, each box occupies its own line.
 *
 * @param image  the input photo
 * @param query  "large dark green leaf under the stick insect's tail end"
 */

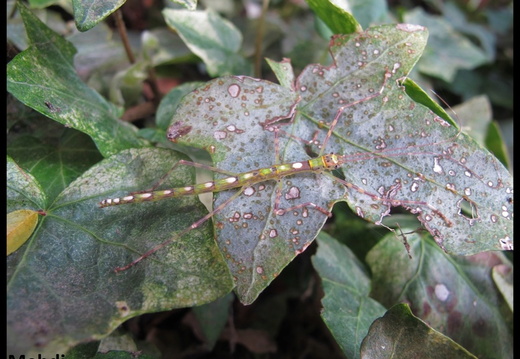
xmin=7 ymin=149 xmax=233 ymax=356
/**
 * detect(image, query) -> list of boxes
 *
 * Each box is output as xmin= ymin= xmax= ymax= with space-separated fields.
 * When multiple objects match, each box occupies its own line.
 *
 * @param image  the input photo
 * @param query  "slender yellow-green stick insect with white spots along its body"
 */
xmin=99 ymin=70 xmax=462 ymax=272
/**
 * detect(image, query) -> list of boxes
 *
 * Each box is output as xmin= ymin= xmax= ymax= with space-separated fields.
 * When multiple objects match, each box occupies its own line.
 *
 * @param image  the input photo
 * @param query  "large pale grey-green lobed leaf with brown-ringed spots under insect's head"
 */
xmin=167 ymin=24 xmax=513 ymax=304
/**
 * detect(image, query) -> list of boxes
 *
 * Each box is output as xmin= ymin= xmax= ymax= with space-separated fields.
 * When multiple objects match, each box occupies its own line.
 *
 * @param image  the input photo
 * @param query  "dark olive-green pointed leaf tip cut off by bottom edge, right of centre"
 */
xmin=361 ymin=304 xmax=476 ymax=359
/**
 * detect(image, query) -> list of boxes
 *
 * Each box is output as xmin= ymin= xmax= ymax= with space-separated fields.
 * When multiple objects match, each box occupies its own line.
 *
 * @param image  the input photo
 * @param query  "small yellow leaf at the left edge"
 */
xmin=7 ymin=209 xmax=38 ymax=255
